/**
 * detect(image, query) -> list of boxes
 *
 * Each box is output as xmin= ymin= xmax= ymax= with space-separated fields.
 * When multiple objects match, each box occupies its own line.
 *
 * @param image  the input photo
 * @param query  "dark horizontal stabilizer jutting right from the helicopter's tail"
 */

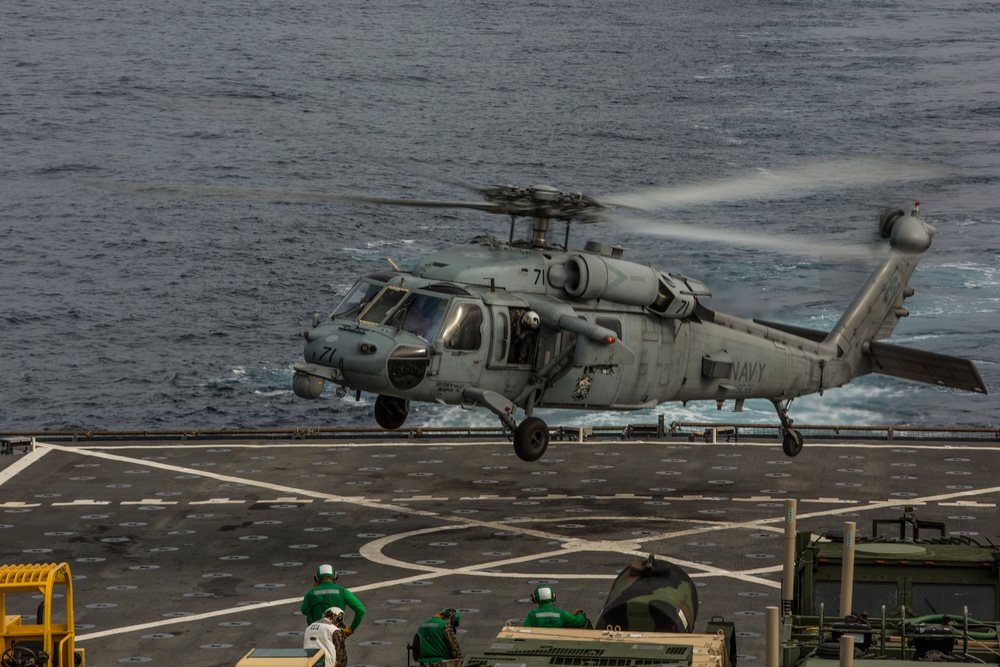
xmin=868 ymin=342 xmax=986 ymax=394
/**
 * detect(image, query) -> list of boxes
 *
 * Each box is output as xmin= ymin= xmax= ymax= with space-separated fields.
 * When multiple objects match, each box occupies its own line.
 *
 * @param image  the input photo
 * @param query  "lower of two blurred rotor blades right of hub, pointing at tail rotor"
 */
xmin=606 ymin=215 xmax=879 ymax=259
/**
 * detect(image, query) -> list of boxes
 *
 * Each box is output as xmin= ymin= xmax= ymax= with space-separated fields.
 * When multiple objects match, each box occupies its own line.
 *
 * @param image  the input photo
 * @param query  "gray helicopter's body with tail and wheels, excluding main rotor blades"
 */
xmin=295 ymin=205 xmax=985 ymax=460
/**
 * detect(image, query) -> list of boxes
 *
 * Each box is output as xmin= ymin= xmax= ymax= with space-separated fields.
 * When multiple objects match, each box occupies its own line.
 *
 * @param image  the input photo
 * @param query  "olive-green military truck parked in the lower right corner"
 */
xmin=780 ymin=508 xmax=1000 ymax=667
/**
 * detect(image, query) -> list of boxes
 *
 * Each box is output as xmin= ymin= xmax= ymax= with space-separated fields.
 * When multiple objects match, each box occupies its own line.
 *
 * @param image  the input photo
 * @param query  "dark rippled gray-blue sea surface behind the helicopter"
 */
xmin=0 ymin=0 xmax=1000 ymax=431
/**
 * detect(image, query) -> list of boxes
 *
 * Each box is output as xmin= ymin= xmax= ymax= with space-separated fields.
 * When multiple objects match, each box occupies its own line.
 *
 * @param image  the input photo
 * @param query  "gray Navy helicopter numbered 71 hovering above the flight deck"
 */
xmin=276 ymin=164 xmax=986 ymax=461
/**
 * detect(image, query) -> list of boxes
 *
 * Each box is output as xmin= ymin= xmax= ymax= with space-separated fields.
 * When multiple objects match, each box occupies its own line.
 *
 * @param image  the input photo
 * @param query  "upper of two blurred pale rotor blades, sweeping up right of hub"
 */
xmin=600 ymin=159 xmax=947 ymax=211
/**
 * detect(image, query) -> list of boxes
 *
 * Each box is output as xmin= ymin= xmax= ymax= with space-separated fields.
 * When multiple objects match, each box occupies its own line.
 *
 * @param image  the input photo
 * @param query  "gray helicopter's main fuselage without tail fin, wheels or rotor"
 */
xmin=297 ymin=237 xmax=823 ymax=413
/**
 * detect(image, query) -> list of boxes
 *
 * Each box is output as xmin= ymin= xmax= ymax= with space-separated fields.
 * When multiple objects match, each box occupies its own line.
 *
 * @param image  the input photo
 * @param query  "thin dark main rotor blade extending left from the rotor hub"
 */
xmin=89 ymin=180 xmax=507 ymax=213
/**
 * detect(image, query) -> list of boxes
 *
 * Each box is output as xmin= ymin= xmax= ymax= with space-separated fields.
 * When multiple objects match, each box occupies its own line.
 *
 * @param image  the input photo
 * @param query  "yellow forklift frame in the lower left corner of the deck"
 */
xmin=0 ymin=563 xmax=86 ymax=667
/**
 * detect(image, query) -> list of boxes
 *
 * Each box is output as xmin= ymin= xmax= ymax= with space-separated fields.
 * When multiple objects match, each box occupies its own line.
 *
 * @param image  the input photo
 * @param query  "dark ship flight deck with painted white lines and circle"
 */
xmin=0 ymin=437 xmax=1000 ymax=667
